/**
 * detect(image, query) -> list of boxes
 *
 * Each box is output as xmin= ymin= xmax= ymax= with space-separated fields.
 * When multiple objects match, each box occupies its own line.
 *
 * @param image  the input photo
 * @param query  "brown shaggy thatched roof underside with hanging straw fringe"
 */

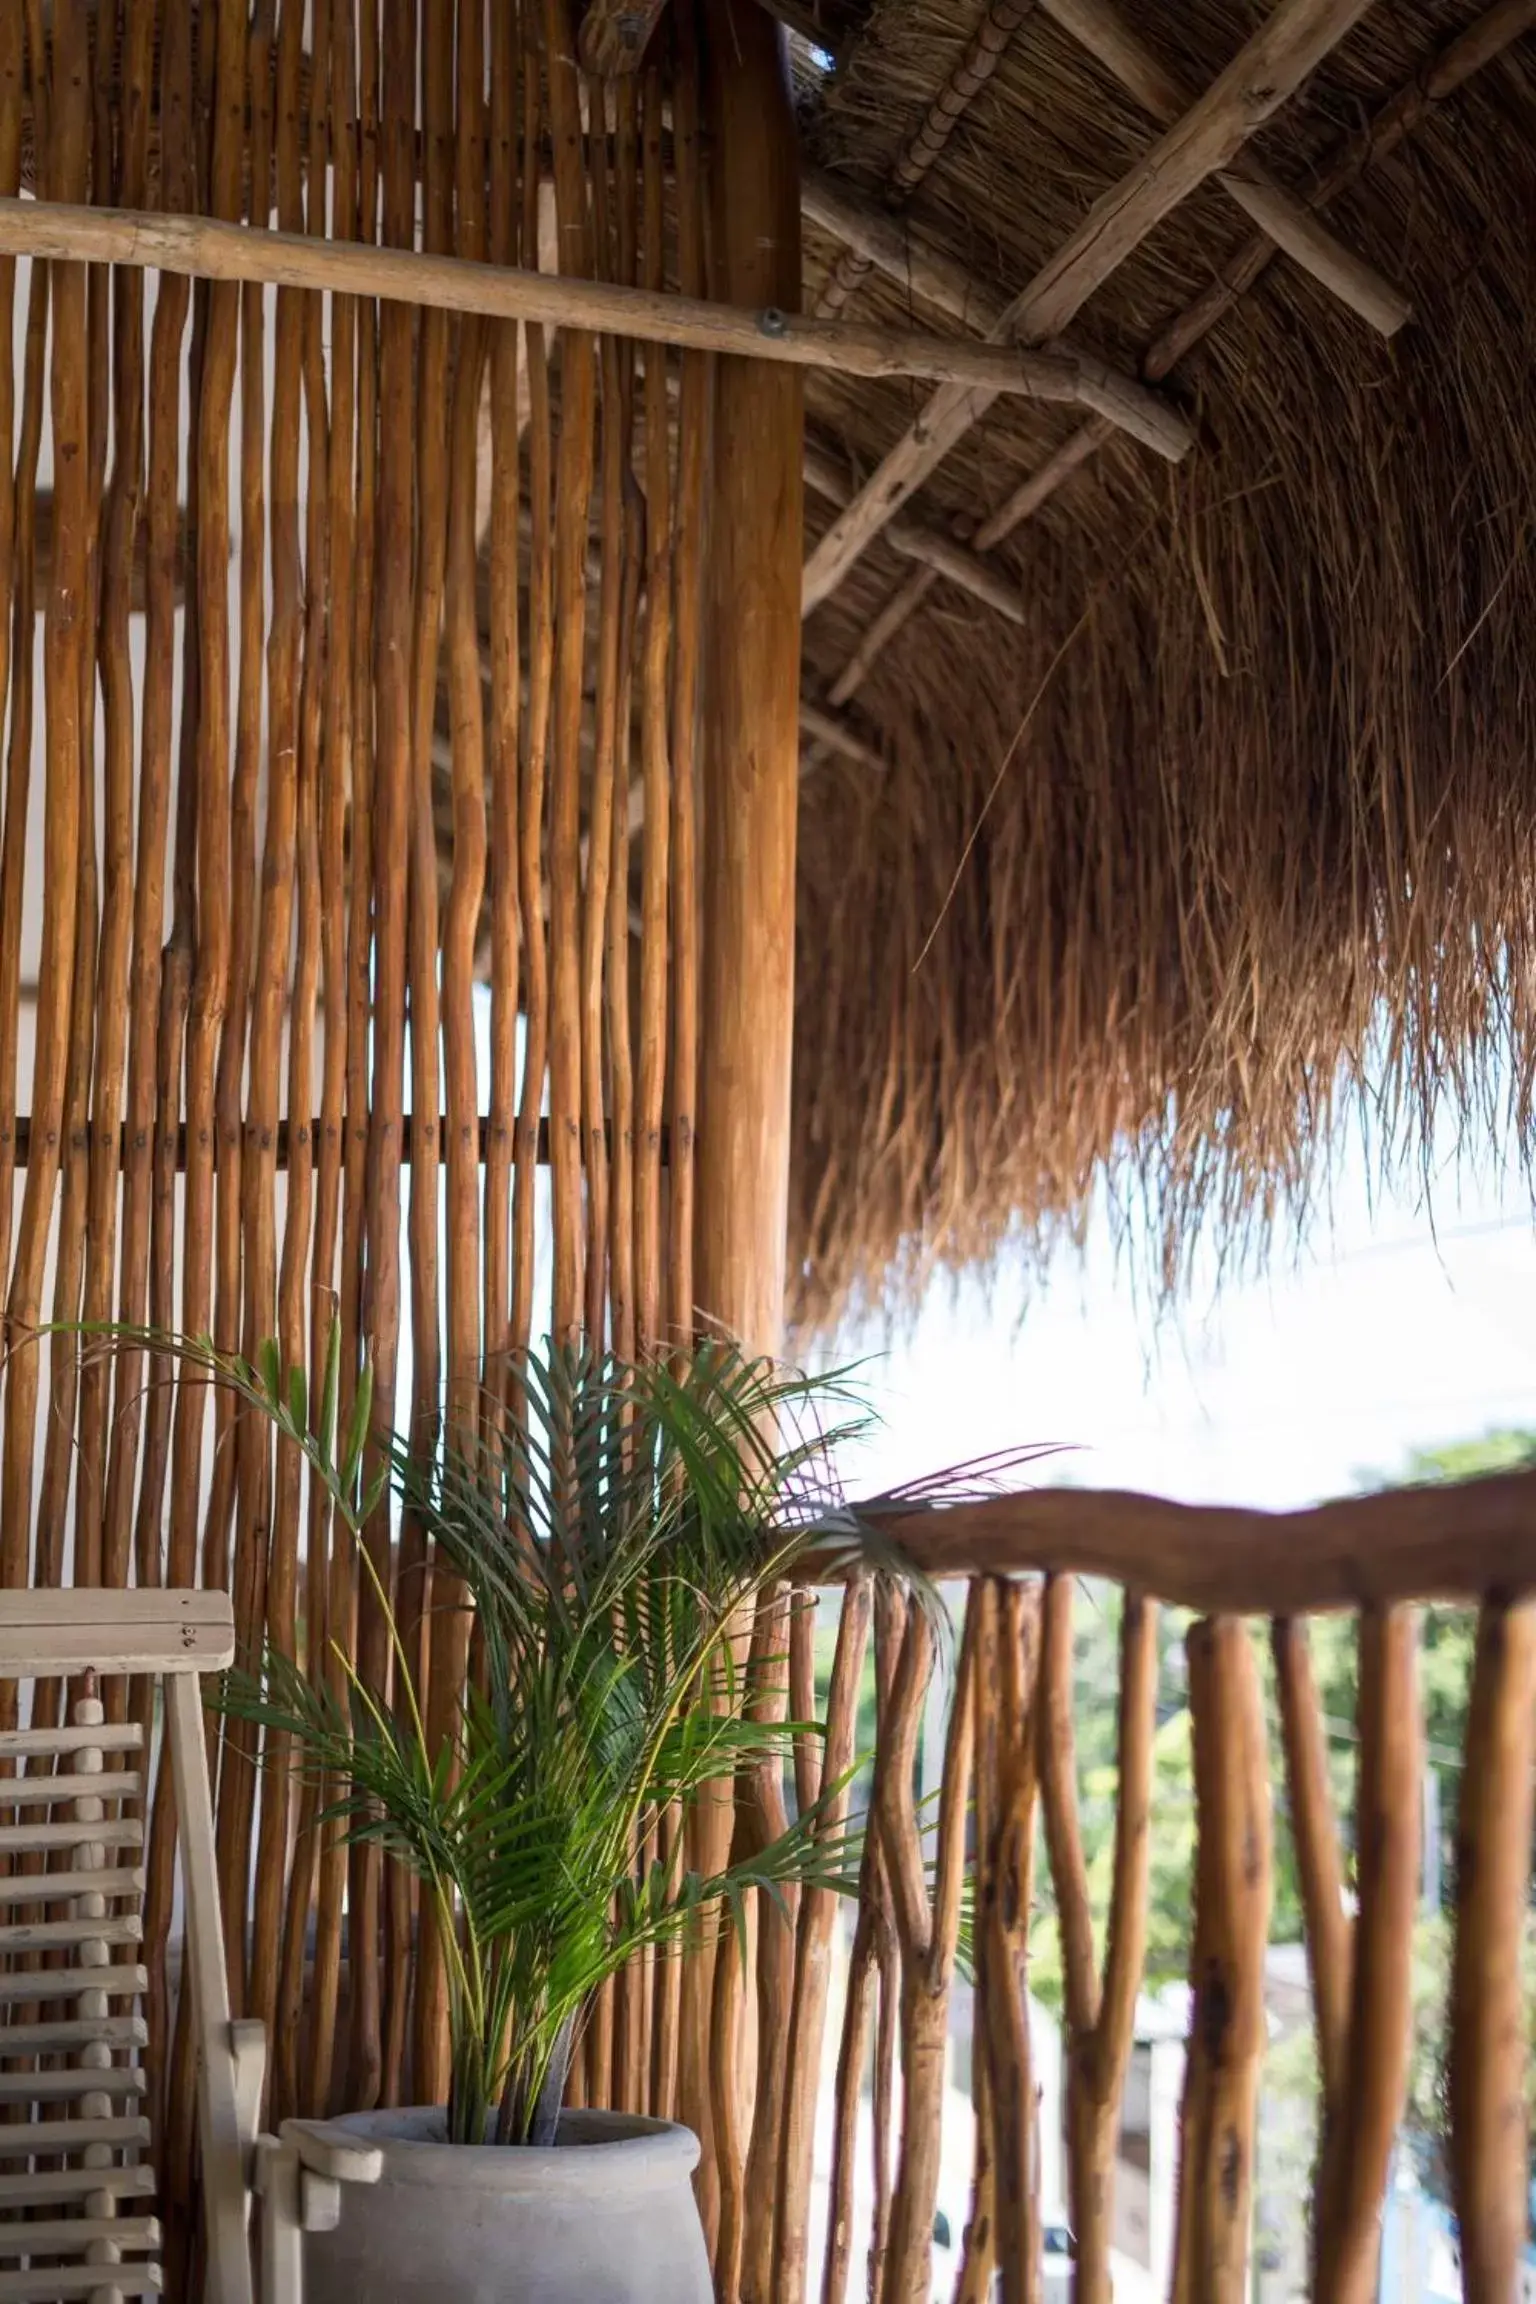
xmin=785 ymin=0 xmax=1536 ymax=1318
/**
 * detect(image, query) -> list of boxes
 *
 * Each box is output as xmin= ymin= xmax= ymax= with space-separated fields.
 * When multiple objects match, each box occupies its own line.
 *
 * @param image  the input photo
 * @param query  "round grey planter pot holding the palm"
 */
xmin=304 ymin=2110 xmax=714 ymax=2304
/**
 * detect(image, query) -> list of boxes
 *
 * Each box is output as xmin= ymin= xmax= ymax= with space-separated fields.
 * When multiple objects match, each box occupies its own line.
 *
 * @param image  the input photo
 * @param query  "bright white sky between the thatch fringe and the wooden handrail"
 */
xmin=845 ymin=1105 xmax=1536 ymax=1507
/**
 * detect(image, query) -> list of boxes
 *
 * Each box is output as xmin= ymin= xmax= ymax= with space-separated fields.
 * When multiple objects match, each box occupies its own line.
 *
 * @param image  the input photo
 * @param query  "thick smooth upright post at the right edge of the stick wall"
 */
xmin=698 ymin=0 xmax=804 ymax=1350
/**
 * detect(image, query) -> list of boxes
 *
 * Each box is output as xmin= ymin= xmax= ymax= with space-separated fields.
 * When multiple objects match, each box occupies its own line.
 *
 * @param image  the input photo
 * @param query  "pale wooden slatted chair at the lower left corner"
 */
xmin=0 ymin=1590 xmax=265 ymax=2304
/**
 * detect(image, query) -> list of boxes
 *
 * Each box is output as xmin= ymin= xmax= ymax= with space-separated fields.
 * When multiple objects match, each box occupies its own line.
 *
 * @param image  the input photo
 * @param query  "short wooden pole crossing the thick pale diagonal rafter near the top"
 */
xmin=1039 ymin=0 xmax=1412 ymax=336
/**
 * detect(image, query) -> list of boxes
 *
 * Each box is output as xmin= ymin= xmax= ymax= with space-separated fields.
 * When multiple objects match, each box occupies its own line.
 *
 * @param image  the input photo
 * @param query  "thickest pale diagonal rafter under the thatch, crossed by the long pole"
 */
xmin=801 ymin=0 xmax=1370 ymax=613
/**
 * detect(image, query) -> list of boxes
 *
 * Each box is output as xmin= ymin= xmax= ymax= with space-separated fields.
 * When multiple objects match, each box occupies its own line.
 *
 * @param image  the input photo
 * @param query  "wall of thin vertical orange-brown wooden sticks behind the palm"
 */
xmin=0 ymin=0 xmax=732 ymax=2260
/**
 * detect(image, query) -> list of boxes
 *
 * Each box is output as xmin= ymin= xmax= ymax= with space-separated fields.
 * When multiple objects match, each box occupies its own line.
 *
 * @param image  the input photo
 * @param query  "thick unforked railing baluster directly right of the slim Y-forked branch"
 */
xmin=1172 ymin=1615 xmax=1271 ymax=2304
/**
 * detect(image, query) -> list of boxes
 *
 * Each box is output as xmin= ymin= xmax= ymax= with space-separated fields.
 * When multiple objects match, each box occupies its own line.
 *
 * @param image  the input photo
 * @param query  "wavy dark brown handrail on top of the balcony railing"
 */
xmin=857 ymin=1472 xmax=1536 ymax=1615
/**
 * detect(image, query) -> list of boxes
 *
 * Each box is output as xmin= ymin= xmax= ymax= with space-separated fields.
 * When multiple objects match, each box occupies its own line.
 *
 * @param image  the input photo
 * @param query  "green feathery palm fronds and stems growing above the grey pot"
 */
xmin=84 ymin=1322 xmax=944 ymax=2138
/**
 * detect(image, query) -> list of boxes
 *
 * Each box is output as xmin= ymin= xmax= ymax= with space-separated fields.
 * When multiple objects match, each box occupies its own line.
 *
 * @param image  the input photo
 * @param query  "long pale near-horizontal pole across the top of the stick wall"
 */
xmin=0 ymin=198 xmax=1193 ymax=463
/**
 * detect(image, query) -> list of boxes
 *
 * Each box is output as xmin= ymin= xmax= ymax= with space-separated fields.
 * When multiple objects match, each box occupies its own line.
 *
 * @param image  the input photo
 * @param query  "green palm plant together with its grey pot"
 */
xmin=193 ymin=1346 xmax=921 ymax=2304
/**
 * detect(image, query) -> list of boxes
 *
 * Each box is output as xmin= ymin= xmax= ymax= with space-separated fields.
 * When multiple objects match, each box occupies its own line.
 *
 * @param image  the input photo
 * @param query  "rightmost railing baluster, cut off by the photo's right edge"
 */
xmin=1451 ymin=1599 xmax=1536 ymax=2304
